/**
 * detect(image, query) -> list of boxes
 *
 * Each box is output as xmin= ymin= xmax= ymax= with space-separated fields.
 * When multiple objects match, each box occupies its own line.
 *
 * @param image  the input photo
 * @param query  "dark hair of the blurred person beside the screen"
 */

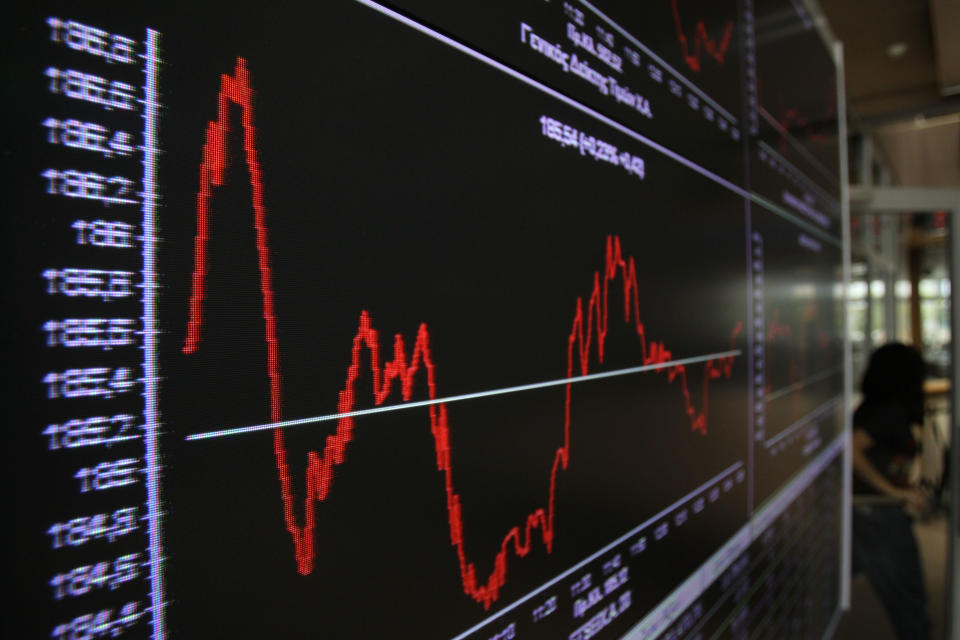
xmin=860 ymin=342 xmax=926 ymax=422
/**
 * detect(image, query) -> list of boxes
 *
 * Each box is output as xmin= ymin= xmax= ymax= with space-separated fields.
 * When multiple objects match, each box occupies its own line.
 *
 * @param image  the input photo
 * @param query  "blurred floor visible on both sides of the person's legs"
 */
xmin=834 ymin=516 xmax=947 ymax=640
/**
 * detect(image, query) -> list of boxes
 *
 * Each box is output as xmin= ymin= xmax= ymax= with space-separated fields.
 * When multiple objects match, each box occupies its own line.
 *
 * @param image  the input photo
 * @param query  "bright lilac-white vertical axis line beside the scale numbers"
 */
xmin=141 ymin=29 xmax=165 ymax=640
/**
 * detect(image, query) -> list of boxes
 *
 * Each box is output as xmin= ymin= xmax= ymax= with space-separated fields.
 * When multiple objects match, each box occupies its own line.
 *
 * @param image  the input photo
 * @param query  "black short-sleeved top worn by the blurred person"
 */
xmin=853 ymin=402 xmax=919 ymax=495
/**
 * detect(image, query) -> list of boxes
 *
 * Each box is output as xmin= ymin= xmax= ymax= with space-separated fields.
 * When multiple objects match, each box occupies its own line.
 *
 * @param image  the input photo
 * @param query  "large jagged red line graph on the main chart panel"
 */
xmin=183 ymin=58 xmax=741 ymax=608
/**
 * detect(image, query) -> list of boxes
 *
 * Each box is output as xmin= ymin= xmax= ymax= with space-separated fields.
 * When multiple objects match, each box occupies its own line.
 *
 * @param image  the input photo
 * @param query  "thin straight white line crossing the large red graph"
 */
xmin=186 ymin=349 xmax=742 ymax=441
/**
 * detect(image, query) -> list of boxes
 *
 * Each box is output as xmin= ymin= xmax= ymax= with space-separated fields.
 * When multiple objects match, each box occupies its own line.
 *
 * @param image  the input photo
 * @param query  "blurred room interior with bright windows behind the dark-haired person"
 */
xmin=808 ymin=0 xmax=960 ymax=639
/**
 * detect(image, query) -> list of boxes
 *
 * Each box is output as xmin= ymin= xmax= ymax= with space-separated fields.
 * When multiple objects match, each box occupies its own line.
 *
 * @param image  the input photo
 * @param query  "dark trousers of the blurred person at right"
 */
xmin=852 ymin=505 xmax=931 ymax=640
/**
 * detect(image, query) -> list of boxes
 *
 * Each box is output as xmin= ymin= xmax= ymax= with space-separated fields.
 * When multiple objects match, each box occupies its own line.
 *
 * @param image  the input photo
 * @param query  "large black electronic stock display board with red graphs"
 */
xmin=3 ymin=0 xmax=845 ymax=640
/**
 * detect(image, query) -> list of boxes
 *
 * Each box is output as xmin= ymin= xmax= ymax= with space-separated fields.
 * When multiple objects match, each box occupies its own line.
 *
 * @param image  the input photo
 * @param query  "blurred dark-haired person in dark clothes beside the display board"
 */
xmin=852 ymin=343 xmax=931 ymax=640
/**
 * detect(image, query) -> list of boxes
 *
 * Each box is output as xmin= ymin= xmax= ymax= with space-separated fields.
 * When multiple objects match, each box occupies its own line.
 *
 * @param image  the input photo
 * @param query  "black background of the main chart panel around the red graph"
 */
xmin=1 ymin=2 xmax=838 ymax=637
